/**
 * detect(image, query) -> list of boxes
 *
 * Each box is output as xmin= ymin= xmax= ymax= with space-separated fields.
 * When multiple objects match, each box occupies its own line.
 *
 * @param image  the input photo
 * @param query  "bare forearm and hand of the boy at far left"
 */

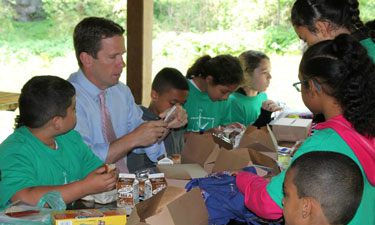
xmin=11 ymin=166 xmax=117 ymax=205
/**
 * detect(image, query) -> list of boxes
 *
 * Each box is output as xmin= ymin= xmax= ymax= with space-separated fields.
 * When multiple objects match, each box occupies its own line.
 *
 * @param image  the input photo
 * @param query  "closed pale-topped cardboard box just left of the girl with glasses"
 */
xmin=270 ymin=118 xmax=312 ymax=142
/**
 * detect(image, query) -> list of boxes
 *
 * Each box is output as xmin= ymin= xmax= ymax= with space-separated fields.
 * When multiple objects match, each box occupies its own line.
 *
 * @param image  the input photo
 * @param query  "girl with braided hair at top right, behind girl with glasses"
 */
xmin=291 ymin=0 xmax=375 ymax=60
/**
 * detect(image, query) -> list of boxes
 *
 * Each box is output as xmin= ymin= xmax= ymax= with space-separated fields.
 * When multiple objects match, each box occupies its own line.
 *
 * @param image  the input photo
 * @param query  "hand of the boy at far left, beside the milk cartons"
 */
xmin=82 ymin=166 xmax=117 ymax=195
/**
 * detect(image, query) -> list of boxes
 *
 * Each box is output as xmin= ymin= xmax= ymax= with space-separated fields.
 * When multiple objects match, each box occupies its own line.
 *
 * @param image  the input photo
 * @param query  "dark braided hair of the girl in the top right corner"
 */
xmin=291 ymin=0 xmax=375 ymax=41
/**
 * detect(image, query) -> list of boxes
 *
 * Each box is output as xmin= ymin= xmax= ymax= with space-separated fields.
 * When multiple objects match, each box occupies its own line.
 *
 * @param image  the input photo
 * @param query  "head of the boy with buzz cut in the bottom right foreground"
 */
xmin=283 ymin=151 xmax=363 ymax=225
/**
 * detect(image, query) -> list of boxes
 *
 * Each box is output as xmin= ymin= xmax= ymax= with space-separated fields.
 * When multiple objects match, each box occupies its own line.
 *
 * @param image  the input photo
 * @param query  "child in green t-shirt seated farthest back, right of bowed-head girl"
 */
xmin=229 ymin=50 xmax=281 ymax=127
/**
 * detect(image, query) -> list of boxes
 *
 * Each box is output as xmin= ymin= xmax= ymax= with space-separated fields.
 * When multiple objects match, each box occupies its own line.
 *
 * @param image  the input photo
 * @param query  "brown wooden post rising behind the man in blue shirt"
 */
xmin=126 ymin=0 xmax=154 ymax=106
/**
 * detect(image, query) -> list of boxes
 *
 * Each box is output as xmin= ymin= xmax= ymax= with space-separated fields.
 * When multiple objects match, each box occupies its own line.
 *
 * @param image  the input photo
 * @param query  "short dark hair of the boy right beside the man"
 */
xmin=152 ymin=67 xmax=189 ymax=95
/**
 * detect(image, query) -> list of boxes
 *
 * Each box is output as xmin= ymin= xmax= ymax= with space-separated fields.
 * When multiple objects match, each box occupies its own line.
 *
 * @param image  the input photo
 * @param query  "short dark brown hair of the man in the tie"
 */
xmin=73 ymin=17 xmax=125 ymax=67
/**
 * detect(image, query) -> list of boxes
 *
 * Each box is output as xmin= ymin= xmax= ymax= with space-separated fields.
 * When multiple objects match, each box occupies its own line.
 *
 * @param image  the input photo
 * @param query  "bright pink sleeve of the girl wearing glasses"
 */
xmin=236 ymin=172 xmax=283 ymax=220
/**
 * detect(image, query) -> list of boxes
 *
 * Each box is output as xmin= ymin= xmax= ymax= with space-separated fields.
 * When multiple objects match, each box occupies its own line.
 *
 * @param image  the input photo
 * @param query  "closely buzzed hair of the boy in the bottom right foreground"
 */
xmin=289 ymin=151 xmax=363 ymax=224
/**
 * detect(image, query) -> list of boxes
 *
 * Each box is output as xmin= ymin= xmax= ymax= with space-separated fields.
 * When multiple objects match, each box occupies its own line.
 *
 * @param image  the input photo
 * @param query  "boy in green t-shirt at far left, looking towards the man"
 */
xmin=0 ymin=76 xmax=116 ymax=208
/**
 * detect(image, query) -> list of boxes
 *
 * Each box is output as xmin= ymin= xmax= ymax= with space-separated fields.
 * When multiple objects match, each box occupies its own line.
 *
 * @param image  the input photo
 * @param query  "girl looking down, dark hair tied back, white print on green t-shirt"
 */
xmin=184 ymin=55 xmax=243 ymax=133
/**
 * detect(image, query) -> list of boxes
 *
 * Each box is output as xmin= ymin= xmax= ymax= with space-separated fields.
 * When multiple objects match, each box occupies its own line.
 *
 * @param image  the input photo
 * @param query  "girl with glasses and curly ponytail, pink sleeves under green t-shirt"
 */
xmin=233 ymin=34 xmax=375 ymax=224
